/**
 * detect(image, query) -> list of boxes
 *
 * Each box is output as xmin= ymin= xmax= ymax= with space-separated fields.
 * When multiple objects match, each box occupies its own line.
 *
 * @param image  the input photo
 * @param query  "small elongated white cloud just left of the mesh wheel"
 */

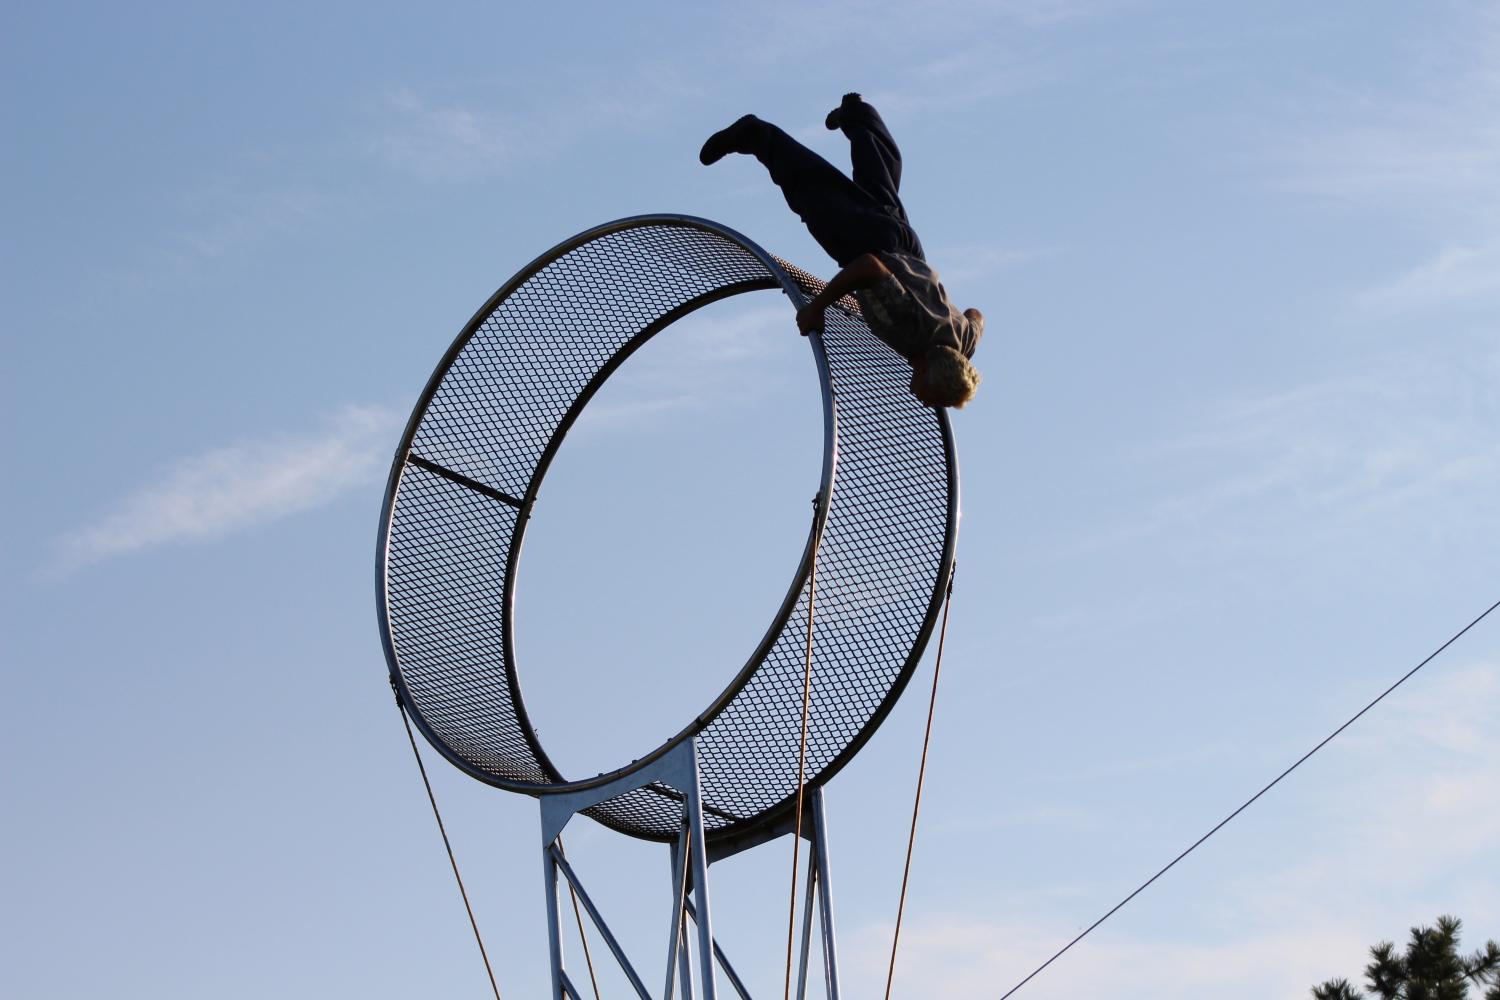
xmin=54 ymin=406 xmax=399 ymax=573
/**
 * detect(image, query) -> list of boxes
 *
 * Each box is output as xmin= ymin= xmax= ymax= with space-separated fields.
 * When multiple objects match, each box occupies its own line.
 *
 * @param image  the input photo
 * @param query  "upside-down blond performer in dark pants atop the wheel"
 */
xmin=698 ymin=93 xmax=984 ymax=406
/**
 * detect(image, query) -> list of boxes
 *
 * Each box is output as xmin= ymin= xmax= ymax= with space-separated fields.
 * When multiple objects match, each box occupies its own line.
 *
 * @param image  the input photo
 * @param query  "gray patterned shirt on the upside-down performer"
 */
xmin=855 ymin=253 xmax=984 ymax=360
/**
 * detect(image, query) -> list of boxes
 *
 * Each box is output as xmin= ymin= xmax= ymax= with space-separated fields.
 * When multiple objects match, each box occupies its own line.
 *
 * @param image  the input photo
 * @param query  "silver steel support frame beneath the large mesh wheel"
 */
xmin=540 ymin=739 xmax=840 ymax=1000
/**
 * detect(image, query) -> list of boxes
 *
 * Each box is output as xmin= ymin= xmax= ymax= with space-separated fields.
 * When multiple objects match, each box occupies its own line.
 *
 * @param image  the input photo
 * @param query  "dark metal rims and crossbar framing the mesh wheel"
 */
xmin=377 ymin=216 xmax=959 ymax=844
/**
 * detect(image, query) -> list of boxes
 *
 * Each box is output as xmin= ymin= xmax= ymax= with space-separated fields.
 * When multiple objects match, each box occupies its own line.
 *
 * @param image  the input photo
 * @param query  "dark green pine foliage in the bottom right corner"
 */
xmin=1313 ymin=916 xmax=1500 ymax=1000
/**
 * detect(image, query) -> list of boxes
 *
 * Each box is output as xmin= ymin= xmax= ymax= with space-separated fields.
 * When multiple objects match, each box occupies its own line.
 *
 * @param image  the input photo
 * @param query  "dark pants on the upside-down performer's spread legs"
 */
xmin=743 ymin=100 xmax=926 ymax=267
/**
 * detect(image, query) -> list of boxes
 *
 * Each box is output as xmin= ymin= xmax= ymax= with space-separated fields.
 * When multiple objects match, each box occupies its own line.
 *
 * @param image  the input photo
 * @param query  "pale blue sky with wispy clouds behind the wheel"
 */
xmin=0 ymin=0 xmax=1500 ymax=1000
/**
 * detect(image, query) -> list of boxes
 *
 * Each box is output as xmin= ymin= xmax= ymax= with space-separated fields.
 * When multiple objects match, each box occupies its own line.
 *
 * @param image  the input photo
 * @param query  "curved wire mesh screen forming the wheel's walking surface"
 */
xmin=380 ymin=216 xmax=957 ymax=840
